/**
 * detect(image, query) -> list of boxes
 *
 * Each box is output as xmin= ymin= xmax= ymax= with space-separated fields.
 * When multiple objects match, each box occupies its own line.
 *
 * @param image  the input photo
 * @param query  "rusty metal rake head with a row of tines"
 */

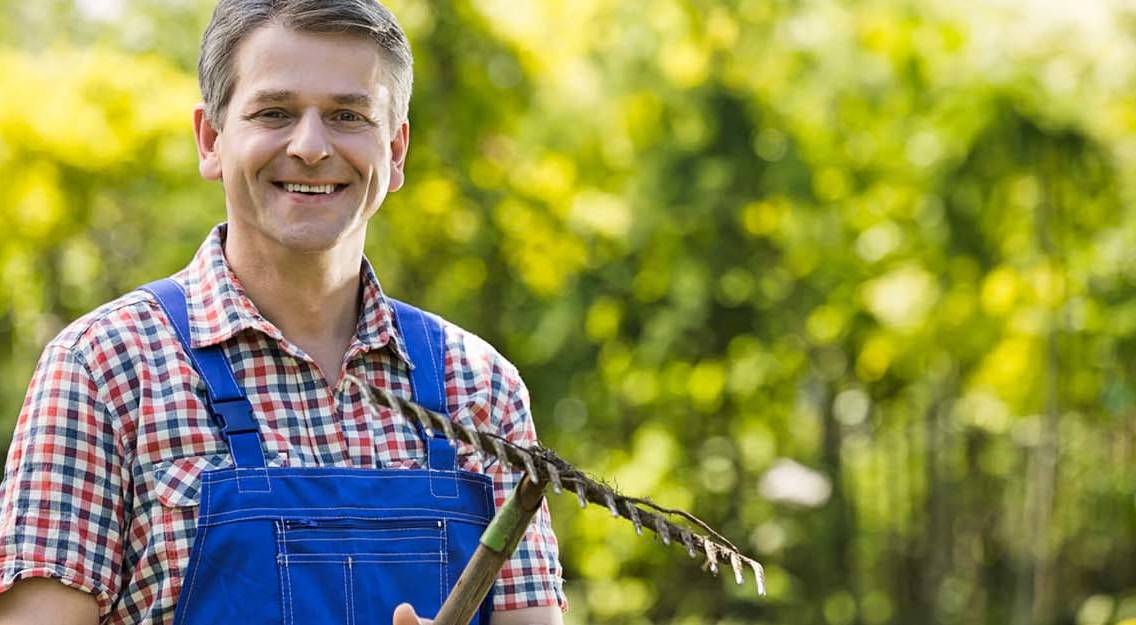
xmin=348 ymin=376 xmax=766 ymax=594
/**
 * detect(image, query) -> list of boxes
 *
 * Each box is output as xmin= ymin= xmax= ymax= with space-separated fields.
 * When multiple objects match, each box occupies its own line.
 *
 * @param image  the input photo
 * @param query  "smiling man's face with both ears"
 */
xmin=195 ymin=25 xmax=409 ymax=255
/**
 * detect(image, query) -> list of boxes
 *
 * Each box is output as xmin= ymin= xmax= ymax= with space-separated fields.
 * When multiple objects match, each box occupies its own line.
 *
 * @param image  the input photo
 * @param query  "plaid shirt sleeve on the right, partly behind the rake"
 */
xmin=487 ymin=377 xmax=568 ymax=610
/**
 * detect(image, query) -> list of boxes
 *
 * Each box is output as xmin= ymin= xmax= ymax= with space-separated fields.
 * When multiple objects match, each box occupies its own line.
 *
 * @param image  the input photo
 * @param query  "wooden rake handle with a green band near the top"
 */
xmin=434 ymin=474 xmax=548 ymax=625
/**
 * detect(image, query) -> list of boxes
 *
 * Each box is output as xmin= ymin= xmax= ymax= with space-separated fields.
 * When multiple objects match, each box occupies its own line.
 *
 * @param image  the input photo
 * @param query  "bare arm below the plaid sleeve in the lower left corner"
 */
xmin=0 ymin=577 xmax=99 ymax=625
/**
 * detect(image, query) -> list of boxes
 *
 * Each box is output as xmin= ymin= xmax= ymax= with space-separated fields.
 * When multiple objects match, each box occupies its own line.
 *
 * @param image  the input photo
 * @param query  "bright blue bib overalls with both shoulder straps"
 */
xmin=143 ymin=280 xmax=494 ymax=625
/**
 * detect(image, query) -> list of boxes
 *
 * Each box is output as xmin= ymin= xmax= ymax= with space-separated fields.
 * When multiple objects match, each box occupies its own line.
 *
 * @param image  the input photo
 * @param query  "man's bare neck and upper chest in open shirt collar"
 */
xmin=225 ymin=225 xmax=362 ymax=383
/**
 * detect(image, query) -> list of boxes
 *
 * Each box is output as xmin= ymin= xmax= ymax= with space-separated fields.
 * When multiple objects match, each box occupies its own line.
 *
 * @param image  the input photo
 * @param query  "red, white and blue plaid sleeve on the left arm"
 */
xmin=0 ymin=344 xmax=124 ymax=616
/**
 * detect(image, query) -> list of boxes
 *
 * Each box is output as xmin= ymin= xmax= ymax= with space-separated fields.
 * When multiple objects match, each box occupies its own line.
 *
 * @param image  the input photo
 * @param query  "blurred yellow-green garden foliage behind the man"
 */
xmin=0 ymin=0 xmax=1136 ymax=625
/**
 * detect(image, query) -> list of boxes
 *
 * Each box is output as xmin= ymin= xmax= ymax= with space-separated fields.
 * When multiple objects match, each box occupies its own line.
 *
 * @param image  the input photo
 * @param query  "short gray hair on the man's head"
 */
xmin=198 ymin=0 xmax=414 ymax=128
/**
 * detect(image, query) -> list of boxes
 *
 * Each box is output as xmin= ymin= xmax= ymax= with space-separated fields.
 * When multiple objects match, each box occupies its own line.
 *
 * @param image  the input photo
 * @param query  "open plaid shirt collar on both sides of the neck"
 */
xmin=177 ymin=224 xmax=410 ymax=364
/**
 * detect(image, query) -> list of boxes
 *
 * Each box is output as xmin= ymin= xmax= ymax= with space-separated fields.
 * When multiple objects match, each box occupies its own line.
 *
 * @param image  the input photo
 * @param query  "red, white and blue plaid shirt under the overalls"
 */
xmin=0 ymin=225 xmax=567 ymax=624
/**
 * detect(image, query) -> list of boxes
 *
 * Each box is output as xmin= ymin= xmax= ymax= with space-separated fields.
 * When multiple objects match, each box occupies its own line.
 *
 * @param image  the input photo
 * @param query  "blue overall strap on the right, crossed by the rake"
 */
xmin=386 ymin=298 xmax=457 ymax=484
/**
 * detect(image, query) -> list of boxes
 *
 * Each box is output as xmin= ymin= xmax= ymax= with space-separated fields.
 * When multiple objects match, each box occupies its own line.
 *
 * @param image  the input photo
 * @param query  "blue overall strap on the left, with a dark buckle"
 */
xmin=142 ymin=278 xmax=266 ymax=469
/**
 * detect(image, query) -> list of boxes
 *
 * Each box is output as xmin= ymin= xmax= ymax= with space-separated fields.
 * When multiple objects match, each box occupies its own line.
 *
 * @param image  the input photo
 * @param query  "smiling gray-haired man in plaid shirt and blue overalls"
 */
xmin=0 ymin=0 xmax=565 ymax=625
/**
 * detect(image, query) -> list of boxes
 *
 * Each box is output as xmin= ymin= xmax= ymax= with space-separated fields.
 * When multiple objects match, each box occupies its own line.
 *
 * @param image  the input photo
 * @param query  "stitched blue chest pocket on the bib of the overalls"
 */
xmin=276 ymin=518 xmax=448 ymax=625
